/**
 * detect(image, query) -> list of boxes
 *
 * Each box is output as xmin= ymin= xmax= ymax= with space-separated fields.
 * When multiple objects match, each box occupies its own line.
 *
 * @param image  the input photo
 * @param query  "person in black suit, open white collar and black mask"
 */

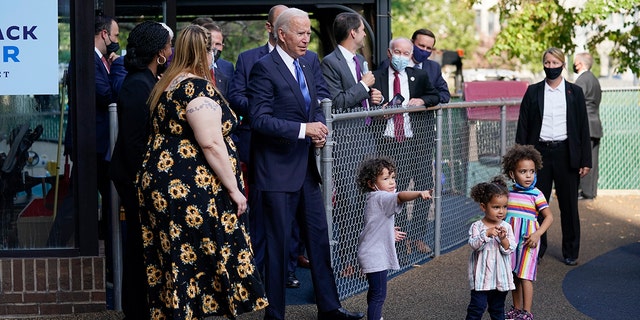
xmin=516 ymin=48 xmax=591 ymax=266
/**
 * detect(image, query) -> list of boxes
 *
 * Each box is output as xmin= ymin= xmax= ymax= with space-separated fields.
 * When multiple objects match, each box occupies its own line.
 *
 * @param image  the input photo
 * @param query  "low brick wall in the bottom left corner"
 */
xmin=0 ymin=257 xmax=106 ymax=319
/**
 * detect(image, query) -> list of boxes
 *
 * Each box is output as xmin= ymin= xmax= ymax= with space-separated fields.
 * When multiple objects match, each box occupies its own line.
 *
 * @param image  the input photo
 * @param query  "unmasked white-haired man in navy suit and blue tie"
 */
xmin=248 ymin=8 xmax=364 ymax=320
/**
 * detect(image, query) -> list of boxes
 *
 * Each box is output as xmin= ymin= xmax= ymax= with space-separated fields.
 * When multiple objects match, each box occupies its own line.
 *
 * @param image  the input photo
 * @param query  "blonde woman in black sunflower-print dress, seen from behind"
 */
xmin=136 ymin=25 xmax=268 ymax=319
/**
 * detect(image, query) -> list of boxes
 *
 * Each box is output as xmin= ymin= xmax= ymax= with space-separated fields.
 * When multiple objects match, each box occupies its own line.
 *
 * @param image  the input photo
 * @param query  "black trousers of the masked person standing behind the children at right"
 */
xmin=536 ymin=143 xmax=580 ymax=259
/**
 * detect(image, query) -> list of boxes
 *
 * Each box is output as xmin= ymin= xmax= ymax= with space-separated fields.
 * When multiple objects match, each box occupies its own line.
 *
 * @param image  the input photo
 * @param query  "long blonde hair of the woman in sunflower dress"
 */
xmin=148 ymin=25 xmax=211 ymax=111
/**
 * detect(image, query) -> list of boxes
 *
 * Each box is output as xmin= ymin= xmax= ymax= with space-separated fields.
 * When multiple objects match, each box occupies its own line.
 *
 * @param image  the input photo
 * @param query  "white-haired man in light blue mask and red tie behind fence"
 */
xmin=373 ymin=38 xmax=440 ymax=253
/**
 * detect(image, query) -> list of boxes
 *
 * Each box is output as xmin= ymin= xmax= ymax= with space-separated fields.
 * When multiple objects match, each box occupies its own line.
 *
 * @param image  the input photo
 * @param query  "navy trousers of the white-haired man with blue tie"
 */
xmin=261 ymin=172 xmax=340 ymax=319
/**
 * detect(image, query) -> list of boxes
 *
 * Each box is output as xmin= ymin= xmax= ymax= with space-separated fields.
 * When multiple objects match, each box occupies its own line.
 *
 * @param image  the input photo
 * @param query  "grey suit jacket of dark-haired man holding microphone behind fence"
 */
xmin=321 ymin=47 xmax=369 ymax=110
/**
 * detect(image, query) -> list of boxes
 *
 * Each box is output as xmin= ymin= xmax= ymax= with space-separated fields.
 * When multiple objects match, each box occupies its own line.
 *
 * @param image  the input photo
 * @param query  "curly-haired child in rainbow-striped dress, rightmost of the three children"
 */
xmin=502 ymin=145 xmax=553 ymax=320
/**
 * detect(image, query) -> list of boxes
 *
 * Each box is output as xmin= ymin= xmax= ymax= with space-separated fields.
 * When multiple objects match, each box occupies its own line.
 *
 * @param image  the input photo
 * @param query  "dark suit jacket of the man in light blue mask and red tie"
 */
xmin=373 ymin=67 xmax=440 ymax=107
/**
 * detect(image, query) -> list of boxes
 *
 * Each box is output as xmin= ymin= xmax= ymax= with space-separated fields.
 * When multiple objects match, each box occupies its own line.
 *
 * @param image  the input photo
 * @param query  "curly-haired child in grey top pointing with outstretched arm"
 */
xmin=357 ymin=157 xmax=431 ymax=320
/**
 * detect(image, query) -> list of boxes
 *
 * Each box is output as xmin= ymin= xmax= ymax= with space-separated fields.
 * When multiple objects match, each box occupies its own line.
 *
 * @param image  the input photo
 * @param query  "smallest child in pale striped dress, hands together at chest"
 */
xmin=466 ymin=177 xmax=516 ymax=320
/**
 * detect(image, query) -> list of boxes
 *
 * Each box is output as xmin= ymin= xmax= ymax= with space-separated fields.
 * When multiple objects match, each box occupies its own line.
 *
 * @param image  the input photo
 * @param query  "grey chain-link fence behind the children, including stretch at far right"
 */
xmin=320 ymin=89 xmax=640 ymax=298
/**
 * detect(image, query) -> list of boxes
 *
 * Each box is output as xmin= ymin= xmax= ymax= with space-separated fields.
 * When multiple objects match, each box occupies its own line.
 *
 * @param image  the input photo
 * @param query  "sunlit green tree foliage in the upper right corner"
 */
xmin=468 ymin=0 xmax=640 ymax=75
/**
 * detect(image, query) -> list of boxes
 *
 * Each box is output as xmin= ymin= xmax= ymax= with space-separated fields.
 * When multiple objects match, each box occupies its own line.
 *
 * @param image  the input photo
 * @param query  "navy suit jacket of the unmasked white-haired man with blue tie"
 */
xmin=247 ymin=49 xmax=326 ymax=192
